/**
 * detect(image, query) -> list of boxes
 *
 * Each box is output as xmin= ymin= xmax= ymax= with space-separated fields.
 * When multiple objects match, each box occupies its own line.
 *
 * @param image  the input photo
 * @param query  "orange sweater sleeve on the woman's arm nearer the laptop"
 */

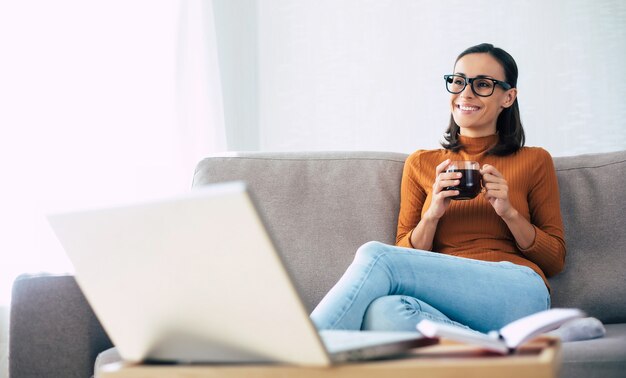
xmin=396 ymin=151 xmax=426 ymax=248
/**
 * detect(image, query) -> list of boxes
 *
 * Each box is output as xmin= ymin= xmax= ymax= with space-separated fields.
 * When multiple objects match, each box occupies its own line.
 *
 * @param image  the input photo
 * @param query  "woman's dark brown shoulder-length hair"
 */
xmin=441 ymin=43 xmax=525 ymax=156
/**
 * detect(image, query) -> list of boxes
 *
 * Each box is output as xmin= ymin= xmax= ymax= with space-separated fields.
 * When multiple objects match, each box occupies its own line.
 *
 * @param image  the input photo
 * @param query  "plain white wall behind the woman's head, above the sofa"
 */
xmin=246 ymin=0 xmax=626 ymax=156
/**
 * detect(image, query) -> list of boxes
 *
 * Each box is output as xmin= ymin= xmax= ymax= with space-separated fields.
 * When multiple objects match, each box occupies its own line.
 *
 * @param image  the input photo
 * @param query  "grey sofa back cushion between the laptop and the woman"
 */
xmin=193 ymin=152 xmax=406 ymax=310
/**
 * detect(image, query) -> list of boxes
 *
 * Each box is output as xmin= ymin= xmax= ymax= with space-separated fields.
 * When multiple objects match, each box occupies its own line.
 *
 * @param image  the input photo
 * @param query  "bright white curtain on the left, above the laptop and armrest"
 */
xmin=0 ymin=0 xmax=226 ymax=308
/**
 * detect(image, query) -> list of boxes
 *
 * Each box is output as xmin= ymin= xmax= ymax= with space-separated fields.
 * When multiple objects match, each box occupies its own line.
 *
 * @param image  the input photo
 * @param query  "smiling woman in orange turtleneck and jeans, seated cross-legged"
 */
xmin=311 ymin=44 xmax=565 ymax=332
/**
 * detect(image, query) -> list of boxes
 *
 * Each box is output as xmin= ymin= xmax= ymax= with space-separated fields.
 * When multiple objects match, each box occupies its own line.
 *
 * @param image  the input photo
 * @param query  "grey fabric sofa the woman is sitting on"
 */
xmin=9 ymin=151 xmax=626 ymax=378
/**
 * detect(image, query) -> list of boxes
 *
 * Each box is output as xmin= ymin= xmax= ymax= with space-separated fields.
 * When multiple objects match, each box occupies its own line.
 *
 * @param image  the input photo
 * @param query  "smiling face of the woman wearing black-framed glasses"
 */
xmin=450 ymin=53 xmax=517 ymax=137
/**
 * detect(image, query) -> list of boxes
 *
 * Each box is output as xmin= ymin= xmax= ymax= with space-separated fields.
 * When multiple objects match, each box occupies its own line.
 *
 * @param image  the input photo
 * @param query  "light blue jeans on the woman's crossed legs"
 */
xmin=311 ymin=242 xmax=550 ymax=333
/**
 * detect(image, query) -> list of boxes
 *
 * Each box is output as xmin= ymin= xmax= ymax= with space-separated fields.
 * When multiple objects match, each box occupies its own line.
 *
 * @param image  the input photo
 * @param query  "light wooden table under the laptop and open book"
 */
xmin=96 ymin=338 xmax=561 ymax=378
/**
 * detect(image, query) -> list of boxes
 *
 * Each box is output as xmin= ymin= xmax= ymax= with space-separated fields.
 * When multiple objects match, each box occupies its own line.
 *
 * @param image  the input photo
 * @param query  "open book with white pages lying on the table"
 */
xmin=417 ymin=308 xmax=585 ymax=354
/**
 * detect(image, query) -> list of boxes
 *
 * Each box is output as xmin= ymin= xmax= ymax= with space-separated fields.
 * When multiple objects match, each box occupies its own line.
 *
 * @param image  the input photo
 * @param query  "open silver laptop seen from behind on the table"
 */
xmin=48 ymin=182 xmax=435 ymax=366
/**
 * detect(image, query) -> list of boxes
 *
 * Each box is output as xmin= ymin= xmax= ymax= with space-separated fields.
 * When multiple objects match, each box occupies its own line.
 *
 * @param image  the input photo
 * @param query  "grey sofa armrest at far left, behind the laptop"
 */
xmin=9 ymin=275 xmax=112 ymax=378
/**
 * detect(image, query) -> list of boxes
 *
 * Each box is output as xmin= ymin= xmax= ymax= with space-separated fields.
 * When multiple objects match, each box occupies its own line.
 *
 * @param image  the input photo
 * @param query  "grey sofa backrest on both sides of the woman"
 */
xmin=193 ymin=151 xmax=626 ymax=322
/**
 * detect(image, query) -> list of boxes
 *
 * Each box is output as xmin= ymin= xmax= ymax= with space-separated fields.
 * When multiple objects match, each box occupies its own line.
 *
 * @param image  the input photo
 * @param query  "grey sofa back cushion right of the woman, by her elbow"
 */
xmin=550 ymin=151 xmax=626 ymax=323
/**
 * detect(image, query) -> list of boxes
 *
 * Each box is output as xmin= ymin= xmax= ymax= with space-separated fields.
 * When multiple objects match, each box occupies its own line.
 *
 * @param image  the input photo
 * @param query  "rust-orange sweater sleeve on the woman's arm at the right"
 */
xmin=517 ymin=149 xmax=565 ymax=277
